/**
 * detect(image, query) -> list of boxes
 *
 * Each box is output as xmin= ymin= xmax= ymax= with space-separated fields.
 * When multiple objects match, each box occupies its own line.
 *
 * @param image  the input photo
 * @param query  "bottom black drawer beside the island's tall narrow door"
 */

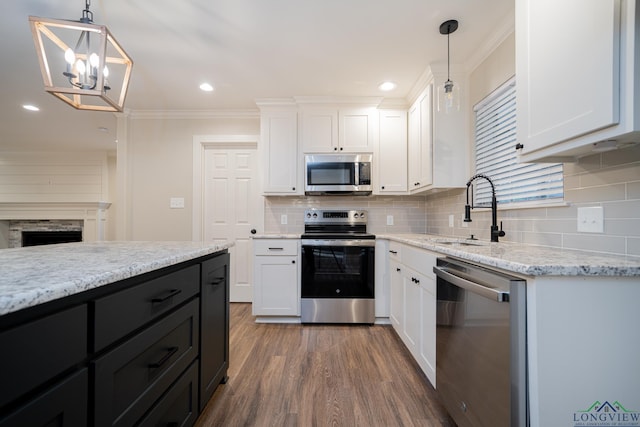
xmin=136 ymin=361 xmax=198 ymax=427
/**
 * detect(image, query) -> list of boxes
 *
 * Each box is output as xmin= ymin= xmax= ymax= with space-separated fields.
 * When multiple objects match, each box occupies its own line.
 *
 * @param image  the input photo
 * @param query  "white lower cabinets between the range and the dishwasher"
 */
xmin=389 ymin=242 xmax=437 ymax=387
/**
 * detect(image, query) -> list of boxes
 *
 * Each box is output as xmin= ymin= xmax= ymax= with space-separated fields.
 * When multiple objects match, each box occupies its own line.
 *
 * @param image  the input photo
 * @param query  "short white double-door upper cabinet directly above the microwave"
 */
xmin=300 ymin=105 xmax=377 ymax=153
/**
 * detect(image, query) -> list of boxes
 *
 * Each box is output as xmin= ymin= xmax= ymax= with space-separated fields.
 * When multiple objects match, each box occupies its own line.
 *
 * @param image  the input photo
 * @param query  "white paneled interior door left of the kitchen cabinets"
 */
xmin=202 ymin=147 xmax=263 ymax=302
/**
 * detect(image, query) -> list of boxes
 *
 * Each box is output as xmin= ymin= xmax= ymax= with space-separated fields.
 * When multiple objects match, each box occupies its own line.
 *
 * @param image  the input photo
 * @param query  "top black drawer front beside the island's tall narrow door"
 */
xmin=92 ymin=265 xmax=200 ymax=352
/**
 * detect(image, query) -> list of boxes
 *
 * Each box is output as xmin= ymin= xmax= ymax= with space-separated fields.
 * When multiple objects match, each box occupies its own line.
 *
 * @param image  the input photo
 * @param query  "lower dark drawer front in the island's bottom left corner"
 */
xmin=0 ymin=368 xmax=89 ymax=427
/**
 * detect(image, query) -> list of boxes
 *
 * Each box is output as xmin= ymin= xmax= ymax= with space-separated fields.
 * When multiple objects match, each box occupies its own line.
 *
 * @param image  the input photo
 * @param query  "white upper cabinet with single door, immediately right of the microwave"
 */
xmin=373 ymin=110 xmax=407 ymax=194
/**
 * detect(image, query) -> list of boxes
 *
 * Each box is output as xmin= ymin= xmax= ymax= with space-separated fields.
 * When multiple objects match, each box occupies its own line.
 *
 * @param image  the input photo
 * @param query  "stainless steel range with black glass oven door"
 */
xmin=300 ymin=209 xmax=375 ymax=324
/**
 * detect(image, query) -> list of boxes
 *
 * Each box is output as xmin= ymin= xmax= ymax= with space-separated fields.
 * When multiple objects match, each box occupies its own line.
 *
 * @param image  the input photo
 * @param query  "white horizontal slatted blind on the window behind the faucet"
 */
xmin=473 ymin=78 xmax=564 ymax=206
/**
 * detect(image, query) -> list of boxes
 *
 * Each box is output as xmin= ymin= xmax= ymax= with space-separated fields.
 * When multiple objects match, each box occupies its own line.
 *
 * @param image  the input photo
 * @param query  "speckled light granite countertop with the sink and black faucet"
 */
xmin=376 ymin=234 xmax=640 ymax=277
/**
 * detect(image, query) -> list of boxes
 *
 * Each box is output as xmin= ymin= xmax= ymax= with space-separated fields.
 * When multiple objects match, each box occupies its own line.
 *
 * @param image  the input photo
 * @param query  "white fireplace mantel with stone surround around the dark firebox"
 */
xmin=0 ymin=202 xmax=111 ymax=247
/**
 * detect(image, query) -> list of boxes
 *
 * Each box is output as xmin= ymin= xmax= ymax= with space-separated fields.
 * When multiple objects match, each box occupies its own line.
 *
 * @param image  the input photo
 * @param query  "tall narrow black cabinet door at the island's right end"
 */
xmin=200 ymin=253 xmax=229 ymax=411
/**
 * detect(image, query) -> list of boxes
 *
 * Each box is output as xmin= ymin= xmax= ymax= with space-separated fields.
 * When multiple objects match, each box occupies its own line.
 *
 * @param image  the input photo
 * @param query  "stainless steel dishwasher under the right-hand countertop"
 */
xmin=433 ymin=258 xmax=528 ymax=427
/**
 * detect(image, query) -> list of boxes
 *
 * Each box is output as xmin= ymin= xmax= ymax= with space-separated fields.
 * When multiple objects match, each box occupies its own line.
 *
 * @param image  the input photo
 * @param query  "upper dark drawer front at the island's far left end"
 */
xmin=0 ymin=305 xmax=87 ymax=407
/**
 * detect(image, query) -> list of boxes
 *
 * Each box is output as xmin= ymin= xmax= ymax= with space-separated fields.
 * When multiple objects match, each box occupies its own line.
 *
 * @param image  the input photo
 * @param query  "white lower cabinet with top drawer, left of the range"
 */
xmin=252 ymin=239 xmax=300 ymax=316
